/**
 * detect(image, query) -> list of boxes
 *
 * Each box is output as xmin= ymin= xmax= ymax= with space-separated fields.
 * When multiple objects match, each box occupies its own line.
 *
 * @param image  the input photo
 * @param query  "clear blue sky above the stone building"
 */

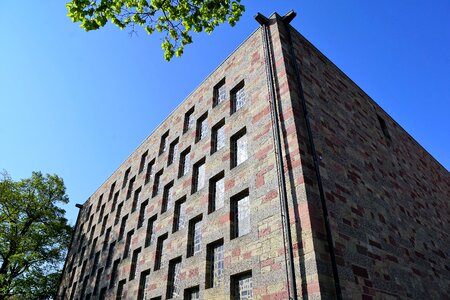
xmin=0 ymin=0 xmax=450 ymax=224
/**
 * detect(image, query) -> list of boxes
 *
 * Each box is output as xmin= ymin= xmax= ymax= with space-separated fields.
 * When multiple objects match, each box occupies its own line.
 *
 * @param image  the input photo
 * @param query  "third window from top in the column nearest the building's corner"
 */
xmin=230 ymin=190 xmax=251 ymax=238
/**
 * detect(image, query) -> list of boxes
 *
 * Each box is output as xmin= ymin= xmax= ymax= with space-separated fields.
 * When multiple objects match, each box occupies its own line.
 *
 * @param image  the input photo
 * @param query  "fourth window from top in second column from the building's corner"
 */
xmin=205 ymin=239 xmax=225 ymax=288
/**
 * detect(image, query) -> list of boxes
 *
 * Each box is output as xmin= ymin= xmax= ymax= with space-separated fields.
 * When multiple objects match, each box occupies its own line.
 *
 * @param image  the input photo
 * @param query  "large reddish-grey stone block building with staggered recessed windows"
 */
xmin=58 ymin=13 xmax=450 ymax=300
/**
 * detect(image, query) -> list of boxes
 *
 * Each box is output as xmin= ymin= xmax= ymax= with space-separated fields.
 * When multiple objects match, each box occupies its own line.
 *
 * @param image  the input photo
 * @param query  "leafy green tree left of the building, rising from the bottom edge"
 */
xmin=0 ymin=172 xmax=72 ymax=300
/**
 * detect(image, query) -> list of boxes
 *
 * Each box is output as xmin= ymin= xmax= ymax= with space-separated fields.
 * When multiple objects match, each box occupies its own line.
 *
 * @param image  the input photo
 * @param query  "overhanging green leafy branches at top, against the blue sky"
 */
xmin=66 ymin=0 xmax=244 ymax=60
